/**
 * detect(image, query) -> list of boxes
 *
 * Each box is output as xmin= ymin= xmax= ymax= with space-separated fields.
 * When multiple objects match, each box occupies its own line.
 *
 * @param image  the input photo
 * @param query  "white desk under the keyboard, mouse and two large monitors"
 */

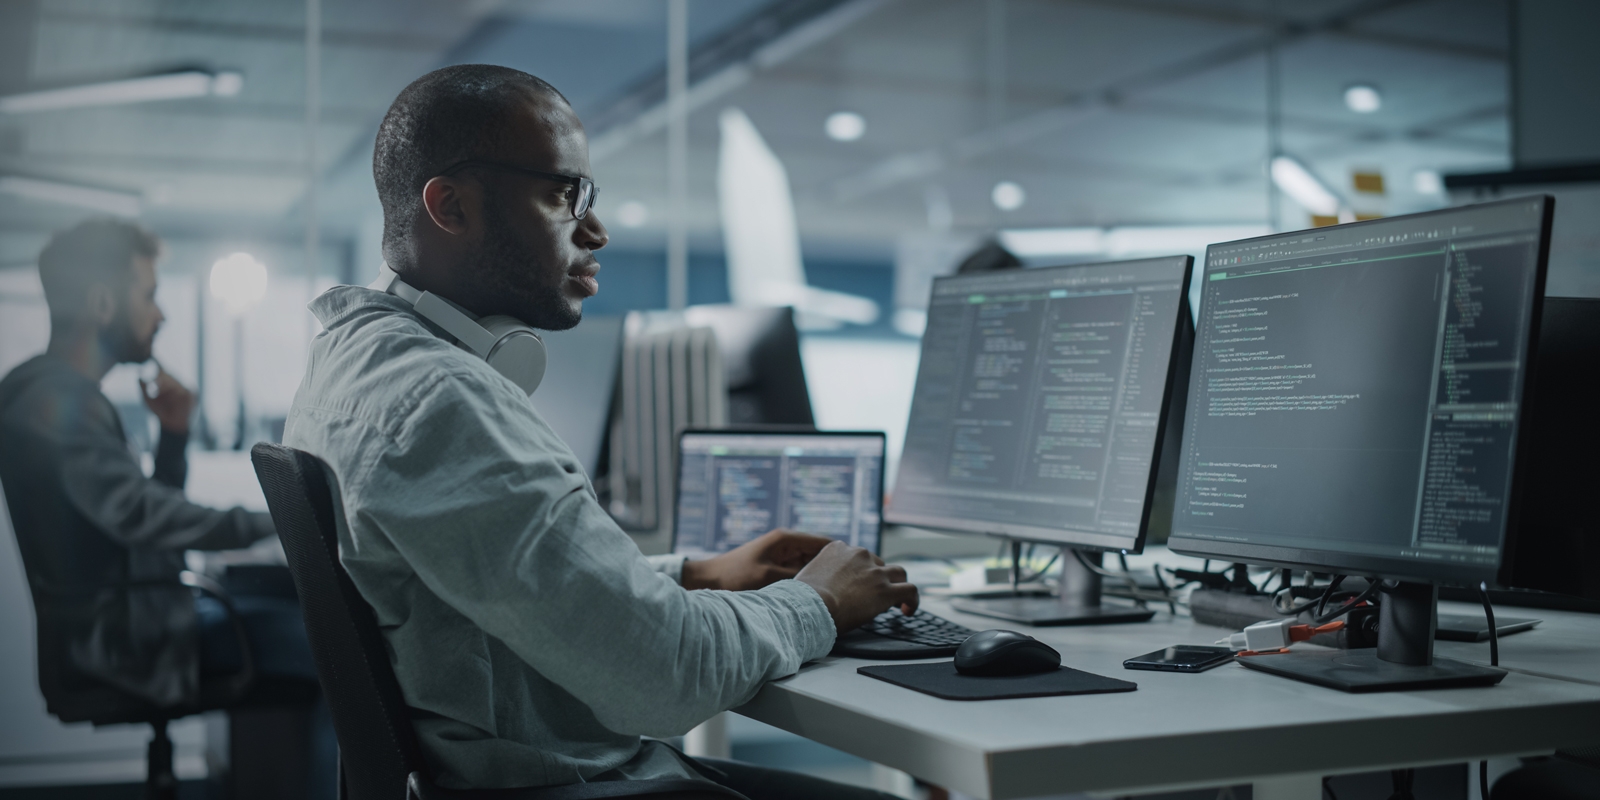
xmin=736 ymin=600 xmax=1600 ymax=800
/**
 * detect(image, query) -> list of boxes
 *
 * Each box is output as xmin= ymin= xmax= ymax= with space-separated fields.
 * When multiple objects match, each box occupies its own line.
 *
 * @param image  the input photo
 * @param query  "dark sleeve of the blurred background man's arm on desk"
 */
xmin=53 ymin=392 xmax=274 ymax=550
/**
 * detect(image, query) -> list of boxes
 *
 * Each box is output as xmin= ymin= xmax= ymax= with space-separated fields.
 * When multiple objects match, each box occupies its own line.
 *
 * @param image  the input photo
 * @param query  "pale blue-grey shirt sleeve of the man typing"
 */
xmin=352 ymin=373 xmax=834 ymax=736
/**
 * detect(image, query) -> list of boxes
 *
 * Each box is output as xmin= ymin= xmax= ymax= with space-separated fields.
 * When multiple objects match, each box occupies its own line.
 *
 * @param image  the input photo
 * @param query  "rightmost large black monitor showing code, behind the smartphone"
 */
xmin=1168 ymin=197 xmax=1554 ymax=691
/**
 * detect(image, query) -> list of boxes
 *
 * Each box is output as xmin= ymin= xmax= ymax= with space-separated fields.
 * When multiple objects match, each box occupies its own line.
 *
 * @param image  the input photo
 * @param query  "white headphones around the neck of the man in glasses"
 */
xmin=366 ymin=264 xmax=544 ymax=395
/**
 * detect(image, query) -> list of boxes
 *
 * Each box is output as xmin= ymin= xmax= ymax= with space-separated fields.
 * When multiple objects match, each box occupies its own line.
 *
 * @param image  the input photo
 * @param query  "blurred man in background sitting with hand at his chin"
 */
xmin=0 ymin=219 xmax=336 ymax=797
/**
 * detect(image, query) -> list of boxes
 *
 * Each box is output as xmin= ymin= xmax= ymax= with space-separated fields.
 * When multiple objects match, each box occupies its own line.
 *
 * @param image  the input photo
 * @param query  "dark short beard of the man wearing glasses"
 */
xmin=478 ymin=197 xmax=584 ymax=331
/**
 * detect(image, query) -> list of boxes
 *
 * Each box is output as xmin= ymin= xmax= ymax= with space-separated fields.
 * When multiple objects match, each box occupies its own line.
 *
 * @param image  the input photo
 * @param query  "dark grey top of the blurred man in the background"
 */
xmin=0 ymin=355 xmax=272 ymax=707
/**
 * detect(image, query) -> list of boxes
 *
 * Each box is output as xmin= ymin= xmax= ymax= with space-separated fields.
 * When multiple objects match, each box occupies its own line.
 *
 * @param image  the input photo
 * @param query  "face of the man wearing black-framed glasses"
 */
xmin=474 ymin=98 xmax=608 ymax=331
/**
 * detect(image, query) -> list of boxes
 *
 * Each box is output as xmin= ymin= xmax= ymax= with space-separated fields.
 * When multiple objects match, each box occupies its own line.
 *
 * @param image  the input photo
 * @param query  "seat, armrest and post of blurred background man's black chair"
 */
xmin=27 ymin=571 xmax=317 ymax=800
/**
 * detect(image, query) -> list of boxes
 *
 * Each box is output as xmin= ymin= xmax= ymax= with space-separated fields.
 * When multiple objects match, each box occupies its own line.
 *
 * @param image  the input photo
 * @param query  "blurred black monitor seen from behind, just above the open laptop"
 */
xmin=683 ymin=306 xmax=816 ymax=426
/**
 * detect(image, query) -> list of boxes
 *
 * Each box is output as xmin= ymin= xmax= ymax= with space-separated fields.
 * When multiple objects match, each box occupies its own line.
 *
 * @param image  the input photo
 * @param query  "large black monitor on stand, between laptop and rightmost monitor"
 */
xmin=886 ymin=256 xmax=1194 ymax=624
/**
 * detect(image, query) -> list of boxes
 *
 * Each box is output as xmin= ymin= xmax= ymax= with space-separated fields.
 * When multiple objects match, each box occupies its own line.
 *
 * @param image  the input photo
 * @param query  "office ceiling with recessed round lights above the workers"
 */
xmin=0 ymin=0 xmax=1509 ymax=266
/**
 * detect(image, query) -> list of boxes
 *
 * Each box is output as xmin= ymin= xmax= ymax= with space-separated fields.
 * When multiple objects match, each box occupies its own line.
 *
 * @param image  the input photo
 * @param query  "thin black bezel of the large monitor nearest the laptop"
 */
xmin=883 ymin=256 xmax=1195 ymax=554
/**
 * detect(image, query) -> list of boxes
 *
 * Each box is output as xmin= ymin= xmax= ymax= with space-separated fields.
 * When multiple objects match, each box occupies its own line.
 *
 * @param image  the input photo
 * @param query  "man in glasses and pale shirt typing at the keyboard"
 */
xmin=285 ymin=66 xmax=917 ymax=798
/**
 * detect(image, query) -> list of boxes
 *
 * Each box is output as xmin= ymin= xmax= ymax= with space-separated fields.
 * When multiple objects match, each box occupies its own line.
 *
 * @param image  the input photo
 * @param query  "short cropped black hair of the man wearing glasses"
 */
xmin=373 ymin=64 xmax=566 ymax=254
